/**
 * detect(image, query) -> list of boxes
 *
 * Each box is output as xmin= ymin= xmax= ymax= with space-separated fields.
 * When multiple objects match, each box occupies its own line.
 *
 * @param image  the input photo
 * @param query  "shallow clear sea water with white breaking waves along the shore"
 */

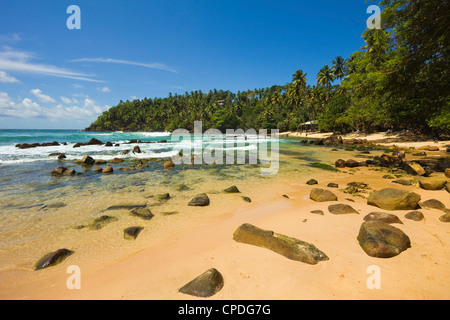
xmin=0 ymin=130 xmax=335 ymax=272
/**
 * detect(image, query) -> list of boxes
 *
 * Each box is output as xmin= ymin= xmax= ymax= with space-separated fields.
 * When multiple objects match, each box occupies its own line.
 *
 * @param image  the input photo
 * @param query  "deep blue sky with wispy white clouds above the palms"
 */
xmin=0 ymin=0 xmax=373 ymax=129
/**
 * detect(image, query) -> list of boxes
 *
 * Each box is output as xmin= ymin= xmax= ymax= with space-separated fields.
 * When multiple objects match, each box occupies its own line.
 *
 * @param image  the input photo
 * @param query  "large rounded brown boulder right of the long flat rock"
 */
xmin=357 ymin=221 xmax=411 ymax=258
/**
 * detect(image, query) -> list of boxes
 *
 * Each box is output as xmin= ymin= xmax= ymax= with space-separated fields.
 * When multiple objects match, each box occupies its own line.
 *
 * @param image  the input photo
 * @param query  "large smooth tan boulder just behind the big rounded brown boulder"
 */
xmin=367 ymin=188 xmax=421 ymax=210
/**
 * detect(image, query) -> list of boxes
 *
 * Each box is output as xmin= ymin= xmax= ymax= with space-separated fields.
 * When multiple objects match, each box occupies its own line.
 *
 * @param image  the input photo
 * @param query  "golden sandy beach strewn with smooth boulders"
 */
xmin=0 ymin=134 xmax=450 ymax=300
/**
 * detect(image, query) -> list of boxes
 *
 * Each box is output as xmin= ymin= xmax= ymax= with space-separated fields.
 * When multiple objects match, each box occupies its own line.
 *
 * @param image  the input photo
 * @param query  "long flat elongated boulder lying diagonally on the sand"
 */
xmin=233 ymin=223 xmax=328 ymax=264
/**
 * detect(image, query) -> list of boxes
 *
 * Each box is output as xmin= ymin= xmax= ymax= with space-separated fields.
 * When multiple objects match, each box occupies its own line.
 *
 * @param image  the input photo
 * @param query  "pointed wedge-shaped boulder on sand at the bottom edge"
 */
xmin=178 ymin=268 xmax=224 ymax=298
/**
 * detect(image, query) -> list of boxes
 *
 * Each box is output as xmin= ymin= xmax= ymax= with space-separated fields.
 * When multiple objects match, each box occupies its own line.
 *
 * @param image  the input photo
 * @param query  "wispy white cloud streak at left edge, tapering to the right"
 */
xmin=0 ymin=46 xmax=102 ymax=82
